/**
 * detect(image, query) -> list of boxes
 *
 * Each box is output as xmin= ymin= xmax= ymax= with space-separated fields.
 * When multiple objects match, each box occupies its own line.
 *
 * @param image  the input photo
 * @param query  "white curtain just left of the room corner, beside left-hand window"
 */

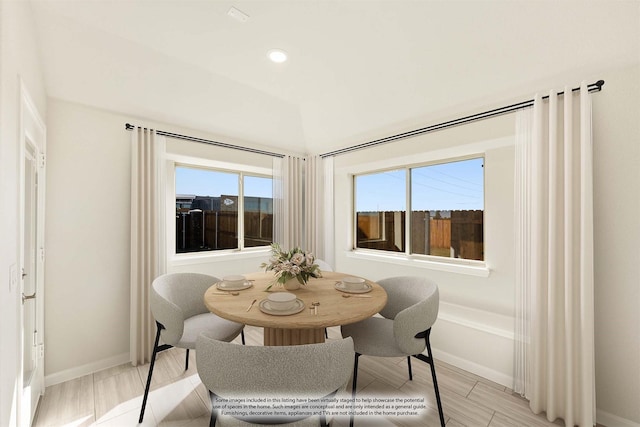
xmin=273 ymin=156 xmax=304 ymax=249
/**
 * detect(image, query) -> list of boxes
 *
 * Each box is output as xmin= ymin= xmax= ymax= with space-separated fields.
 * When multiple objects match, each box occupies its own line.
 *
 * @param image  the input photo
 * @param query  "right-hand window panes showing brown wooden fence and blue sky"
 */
xmin=354 ymin=158 xmax=484 ymax=260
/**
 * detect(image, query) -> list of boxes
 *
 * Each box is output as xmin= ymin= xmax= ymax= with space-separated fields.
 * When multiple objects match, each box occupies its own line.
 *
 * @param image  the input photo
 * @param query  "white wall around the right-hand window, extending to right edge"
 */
xmin=335 ymin=65 xmax=640 ymax=427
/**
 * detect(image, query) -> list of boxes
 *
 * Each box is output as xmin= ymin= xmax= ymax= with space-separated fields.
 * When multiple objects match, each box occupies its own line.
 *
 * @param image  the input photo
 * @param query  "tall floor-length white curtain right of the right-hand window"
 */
xmin=514 ymin=83 xmax=596 ymax=426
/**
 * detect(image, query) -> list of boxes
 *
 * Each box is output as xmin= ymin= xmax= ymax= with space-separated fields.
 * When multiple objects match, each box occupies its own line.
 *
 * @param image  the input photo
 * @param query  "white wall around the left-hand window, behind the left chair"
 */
xmin=45 ymin=99 xmax=284 ymax=385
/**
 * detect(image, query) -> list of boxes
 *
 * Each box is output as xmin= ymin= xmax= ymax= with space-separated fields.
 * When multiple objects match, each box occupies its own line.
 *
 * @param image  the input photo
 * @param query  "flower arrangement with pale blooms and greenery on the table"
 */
xmin=260 ymin=243 xmax=322 ymax=290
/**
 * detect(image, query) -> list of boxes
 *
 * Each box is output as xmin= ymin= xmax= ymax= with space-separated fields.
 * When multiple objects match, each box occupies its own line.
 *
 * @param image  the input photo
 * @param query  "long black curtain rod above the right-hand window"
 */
xmin=320 ymin=80 xmax=604 ymax=158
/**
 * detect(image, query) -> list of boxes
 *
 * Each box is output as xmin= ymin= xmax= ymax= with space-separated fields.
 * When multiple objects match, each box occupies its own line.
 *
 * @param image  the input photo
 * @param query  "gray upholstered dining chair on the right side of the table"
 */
xmin=341 ymin=276 xmax=444 ymax=427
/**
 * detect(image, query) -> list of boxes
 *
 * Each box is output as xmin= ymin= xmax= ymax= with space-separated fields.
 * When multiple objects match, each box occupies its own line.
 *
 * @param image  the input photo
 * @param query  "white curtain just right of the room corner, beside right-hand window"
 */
xmin=304 ymin=156 xmax=335 ymax=266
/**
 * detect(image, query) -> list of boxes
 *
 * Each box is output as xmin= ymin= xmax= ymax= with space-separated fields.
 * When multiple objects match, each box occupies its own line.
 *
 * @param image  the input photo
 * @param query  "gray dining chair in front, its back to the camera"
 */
xmin=196 ymin=332 xmax=353 ymax=427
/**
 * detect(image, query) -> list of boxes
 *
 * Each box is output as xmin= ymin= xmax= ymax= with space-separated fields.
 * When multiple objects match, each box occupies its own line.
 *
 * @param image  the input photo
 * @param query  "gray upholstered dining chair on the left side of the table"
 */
xmin=138 ymin=273 xmax=244 ymax=423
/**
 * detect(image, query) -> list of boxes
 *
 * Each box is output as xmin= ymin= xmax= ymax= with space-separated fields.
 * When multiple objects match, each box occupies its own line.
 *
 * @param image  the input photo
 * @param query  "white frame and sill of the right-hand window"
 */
xmin=350 ymin=152 xmax=489 ymax=268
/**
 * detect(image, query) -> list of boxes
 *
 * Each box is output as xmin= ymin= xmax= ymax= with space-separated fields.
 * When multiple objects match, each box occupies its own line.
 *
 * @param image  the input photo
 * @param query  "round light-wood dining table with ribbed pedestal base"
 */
xmin=204 ymin=272 xmax=387 ymax=345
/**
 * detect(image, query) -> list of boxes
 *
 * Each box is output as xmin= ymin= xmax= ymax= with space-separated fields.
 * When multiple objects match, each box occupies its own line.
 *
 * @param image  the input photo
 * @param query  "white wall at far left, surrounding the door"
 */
xmin=0 ymin=1 xmax=46 ymax=426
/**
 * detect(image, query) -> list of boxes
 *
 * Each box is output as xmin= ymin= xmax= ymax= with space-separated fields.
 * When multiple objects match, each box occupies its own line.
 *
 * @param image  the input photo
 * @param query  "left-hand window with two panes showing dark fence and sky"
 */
xmin=175 ymin=166 xmax=273 ymax=253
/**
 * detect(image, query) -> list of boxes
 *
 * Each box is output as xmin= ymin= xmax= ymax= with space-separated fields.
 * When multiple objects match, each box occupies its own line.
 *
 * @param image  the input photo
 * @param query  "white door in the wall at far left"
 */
xmin=18 ymin=84 xmax=45 ymax=426
